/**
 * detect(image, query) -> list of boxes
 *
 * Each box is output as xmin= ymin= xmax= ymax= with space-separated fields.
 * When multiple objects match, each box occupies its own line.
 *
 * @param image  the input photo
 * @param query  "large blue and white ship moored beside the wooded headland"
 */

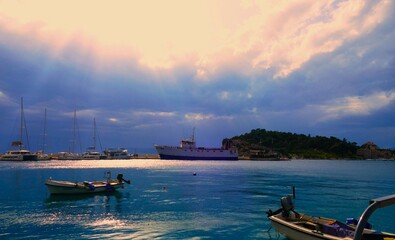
xmin=154 ymin=130 xmax=239 ymax=160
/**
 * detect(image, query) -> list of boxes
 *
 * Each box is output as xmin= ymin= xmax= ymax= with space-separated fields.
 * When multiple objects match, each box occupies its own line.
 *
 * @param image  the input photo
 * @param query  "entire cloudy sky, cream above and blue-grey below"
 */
xmin=0 ymin=0 xmax=395 ymax=152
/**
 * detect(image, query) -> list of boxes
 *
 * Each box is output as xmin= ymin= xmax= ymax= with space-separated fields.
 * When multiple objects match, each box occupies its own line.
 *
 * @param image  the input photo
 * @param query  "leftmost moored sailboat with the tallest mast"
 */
xmin=0 ymin=97 xmax=37 ymax=161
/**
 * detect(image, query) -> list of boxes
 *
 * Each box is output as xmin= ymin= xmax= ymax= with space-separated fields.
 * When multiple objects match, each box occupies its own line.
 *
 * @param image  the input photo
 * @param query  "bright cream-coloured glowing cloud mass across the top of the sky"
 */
xmin=0 ymin=0 xmax=392 ymax=81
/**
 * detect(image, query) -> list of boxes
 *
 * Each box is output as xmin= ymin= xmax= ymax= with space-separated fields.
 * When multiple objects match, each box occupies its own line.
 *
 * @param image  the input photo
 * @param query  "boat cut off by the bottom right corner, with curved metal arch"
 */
xmin=267 ymin=195 xmax=395 ymax=240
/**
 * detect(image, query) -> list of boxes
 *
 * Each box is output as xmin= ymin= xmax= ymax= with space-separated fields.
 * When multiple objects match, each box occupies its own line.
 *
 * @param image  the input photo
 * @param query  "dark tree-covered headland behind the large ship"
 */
xmin=223 ymin=128 xmax=395 ymax=160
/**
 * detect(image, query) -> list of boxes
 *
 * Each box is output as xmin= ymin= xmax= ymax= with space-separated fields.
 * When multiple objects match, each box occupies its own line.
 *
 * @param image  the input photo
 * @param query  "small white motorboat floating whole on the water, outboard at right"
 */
xmin=45 ymin=171 xmax=130 ymax=194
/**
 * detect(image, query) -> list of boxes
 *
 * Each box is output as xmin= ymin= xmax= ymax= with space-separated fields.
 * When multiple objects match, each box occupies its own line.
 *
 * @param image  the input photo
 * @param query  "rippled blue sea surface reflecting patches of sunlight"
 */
xmin=0 ymin=159 xmax=395 ymax=240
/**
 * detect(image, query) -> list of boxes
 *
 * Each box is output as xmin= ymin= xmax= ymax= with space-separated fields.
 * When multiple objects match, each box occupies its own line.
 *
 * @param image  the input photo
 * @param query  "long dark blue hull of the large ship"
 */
xmin=155 ymin=145 xmax=238 ymax=161
